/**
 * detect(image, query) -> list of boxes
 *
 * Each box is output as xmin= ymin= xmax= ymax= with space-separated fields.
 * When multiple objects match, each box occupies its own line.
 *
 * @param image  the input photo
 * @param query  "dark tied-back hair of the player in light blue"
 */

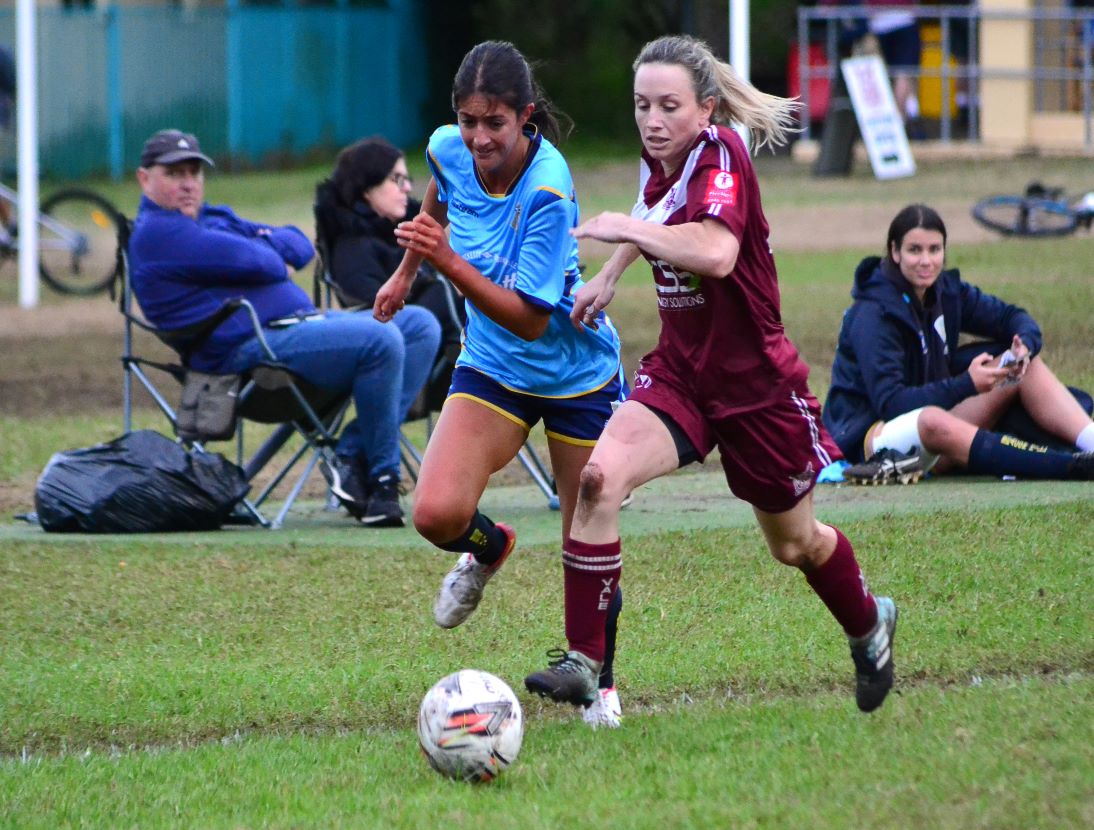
xmin=452 ymin=40 xmax=573 ymax=144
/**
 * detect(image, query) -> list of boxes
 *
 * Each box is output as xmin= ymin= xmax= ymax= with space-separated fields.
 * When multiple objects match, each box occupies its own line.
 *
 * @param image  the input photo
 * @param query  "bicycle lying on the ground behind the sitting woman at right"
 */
xmin=973 ymin=182 xmax=1094 ymax=236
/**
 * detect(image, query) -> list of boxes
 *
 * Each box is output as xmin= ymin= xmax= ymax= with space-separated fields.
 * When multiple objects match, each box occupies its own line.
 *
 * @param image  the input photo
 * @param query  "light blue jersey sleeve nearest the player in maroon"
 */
xmin=516 ymin=188 xmax=574 ymax=311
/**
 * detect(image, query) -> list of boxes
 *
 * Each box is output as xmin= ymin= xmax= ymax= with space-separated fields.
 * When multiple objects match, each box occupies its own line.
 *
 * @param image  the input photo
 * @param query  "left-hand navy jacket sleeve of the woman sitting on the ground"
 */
xmin=849 ymin=302 xmax=976 ymax=421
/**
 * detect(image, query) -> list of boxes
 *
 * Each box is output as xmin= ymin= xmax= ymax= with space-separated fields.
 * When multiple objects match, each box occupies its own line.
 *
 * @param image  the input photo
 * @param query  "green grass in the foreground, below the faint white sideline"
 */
xmin=4 ymin=677 xmax=1094 ymax=830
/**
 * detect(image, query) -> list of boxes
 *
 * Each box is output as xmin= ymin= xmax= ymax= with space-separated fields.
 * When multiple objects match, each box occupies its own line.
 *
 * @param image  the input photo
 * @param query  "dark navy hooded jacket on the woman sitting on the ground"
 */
xmin=823 ymin=257 xmax=1041 ymax=461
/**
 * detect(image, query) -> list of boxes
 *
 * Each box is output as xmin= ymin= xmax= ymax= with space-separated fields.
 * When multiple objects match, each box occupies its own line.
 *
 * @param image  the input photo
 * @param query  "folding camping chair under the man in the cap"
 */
xmin=115 ymin=219 xmax=350 ymax=528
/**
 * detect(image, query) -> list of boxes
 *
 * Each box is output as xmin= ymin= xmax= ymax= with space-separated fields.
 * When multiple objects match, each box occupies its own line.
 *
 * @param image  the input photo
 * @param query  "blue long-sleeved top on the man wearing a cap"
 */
xmin=129 ymin=197 xmax=315 ymax=372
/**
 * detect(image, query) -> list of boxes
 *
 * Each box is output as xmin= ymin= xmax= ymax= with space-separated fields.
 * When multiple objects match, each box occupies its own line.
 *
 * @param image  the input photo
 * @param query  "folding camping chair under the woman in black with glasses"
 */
xmin=312 ymin=179 xmax=559 ymax=510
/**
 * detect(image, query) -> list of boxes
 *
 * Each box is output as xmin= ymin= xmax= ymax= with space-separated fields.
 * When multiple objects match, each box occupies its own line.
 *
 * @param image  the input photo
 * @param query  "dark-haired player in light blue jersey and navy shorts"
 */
xmin=373 ymin=42 xmax=625 ymax=726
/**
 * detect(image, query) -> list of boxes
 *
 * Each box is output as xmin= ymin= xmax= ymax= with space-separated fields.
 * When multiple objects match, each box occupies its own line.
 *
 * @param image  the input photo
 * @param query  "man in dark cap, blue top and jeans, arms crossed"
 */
xmin=129 ymin=130 xmax=440 ymax=527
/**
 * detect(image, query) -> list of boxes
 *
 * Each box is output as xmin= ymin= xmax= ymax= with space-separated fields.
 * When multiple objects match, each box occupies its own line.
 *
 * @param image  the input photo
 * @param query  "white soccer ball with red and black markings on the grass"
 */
xmin=418 ymin=668 xmax=524 ymax=781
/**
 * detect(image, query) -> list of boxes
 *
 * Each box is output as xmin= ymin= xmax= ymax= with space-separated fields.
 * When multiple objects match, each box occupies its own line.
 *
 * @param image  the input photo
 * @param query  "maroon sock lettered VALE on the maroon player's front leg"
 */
xmin=562 ymin=539 xmax=622 ymax=662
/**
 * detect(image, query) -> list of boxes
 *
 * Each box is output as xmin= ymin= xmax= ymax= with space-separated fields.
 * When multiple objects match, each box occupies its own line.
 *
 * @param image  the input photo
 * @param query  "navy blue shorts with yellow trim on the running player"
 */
xmin=449 ymin=366 xmax=627 ymax=446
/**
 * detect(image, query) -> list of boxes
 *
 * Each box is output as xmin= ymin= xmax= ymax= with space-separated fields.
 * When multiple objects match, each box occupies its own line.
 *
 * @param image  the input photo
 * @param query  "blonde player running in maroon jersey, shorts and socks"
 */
xmin=525 ymin=36 xmax=897 ymax=712
